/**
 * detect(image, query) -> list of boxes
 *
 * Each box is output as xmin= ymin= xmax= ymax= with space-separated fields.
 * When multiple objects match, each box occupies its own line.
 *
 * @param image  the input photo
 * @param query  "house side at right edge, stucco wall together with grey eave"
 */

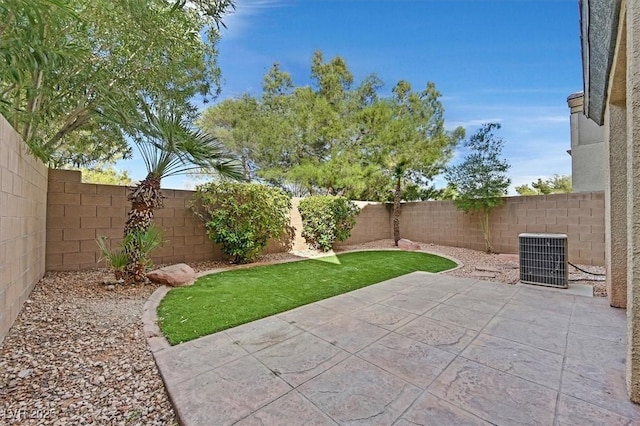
xmin=580 ymin=0 xmax=640 ymax=403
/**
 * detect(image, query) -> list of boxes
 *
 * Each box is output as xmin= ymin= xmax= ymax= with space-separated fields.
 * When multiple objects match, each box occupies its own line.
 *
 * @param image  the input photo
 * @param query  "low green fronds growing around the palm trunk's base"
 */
xmin=96 ymin=224 xmax=166 ymax=280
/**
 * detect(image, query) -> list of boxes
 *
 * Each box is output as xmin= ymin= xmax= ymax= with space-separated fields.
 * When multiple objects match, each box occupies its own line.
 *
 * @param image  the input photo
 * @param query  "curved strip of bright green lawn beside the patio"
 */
xmin=158 ymin=250 xmax=456 ymax=345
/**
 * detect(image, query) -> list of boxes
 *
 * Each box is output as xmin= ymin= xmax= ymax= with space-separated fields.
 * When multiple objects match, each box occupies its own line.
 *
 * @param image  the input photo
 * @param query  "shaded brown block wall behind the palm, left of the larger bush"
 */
xmin=46 ymin=170 xmax=221 ymax=270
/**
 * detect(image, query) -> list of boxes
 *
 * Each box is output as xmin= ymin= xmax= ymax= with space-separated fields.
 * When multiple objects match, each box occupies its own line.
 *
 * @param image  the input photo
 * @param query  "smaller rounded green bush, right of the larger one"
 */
xmin=298 ymin=195 xmax=360 ymax=251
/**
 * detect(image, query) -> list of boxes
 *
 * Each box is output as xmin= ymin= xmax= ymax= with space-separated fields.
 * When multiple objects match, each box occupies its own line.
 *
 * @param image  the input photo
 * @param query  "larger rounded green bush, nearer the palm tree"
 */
xmin=191 ymin=182 xmax=291 ymax=263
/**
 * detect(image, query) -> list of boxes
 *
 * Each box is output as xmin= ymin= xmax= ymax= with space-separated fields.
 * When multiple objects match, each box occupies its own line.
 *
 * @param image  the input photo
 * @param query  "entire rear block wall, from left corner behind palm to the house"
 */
xmin=46 ymin=170 xmax=604 ymax=270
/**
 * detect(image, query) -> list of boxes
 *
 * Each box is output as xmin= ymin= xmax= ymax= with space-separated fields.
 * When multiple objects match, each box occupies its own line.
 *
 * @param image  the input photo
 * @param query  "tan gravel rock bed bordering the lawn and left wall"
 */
xmin=0 ymin=240 xmax=605 ymax=425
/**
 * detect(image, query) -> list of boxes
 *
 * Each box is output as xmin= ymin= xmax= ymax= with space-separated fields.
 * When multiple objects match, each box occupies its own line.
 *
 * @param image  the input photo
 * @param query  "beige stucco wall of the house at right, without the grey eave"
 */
xmin=596 ymin=0 xmax=640 ymax=403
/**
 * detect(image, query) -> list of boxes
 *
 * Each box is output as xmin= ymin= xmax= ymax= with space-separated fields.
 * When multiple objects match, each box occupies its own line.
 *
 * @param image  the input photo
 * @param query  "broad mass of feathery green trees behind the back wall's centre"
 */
xmin=198 ymin=52 xmax=464 ymax=210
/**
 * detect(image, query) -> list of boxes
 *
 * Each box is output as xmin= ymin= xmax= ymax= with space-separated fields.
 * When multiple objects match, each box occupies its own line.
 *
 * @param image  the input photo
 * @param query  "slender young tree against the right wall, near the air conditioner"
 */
xmin=445 ymin=123 xmax=511 ymax=253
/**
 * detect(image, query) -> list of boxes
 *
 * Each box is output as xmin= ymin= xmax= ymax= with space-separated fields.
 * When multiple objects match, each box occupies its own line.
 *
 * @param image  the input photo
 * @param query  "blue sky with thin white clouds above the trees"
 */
xmin=119 ymin=0 xmax=582 ymax=193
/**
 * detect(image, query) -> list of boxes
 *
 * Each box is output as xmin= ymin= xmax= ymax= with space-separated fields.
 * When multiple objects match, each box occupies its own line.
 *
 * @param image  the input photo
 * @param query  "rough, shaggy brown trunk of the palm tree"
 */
xmin=124 ymin=175 xmax=162 ymax=283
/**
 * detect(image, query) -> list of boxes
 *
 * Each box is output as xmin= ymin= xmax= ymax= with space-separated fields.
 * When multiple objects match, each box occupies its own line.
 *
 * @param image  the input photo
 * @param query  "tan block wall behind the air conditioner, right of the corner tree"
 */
xmin=400 ymin=192 xmax=605 ymax=266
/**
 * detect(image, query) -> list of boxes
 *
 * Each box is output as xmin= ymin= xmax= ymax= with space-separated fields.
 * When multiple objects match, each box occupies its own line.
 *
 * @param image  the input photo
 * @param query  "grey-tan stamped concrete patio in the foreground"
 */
xmin=149 ymin=273 xmax=640 ymax=426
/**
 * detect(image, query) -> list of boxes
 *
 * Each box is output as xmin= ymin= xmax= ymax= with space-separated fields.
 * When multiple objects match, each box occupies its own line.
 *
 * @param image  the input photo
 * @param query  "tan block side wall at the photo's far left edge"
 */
xmin=0 ymin=116 xmax=47 ymax=342
